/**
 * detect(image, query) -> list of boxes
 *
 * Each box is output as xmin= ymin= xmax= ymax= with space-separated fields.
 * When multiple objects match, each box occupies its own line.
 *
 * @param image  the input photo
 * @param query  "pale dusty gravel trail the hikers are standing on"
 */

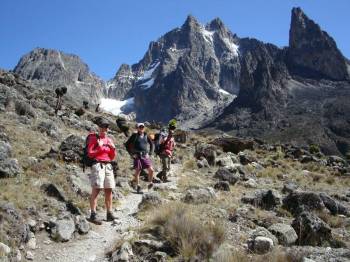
xmin=33 ymin=165 xmax=180 ymax=262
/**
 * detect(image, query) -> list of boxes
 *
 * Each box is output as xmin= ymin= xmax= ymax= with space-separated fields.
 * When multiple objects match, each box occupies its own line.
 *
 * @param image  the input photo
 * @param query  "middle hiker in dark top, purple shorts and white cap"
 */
xmin=125 ymin=123 xmax=154 ymax=193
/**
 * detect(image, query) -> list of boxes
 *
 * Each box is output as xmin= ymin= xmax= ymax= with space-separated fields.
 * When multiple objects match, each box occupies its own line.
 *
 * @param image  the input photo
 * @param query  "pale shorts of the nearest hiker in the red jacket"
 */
xmin=89 ymin=163 xmax=115 ymax=188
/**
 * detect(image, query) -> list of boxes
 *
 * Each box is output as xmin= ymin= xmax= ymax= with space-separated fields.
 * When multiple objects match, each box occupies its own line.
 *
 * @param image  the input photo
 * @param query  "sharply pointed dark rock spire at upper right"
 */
xmin=289 ymin=8 xmax=349 ymax=80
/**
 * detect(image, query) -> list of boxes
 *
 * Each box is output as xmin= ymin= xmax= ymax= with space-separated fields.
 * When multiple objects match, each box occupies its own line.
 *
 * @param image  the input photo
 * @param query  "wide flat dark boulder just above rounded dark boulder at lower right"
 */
xmin=283 ymin=191 xmax=325 ymax=215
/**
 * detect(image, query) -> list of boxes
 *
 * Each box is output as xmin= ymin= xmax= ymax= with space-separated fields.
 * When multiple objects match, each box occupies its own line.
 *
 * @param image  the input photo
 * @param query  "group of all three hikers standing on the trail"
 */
xmin=86 ymin=119 xmax=176 ymax=224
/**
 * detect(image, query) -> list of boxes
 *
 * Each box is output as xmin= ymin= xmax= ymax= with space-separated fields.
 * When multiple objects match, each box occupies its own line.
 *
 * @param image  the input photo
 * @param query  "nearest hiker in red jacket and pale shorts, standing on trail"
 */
xmin=87 ymin=119 xmax=116 ymax=224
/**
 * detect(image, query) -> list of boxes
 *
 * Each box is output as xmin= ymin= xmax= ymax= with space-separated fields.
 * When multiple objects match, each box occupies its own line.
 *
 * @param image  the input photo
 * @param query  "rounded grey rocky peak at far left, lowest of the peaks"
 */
xmin=14 ymin=48 xmax=104 ymax=103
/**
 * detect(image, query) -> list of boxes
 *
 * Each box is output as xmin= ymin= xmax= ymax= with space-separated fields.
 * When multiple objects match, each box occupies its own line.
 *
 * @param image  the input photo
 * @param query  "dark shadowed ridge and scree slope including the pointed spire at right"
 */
xmin=212 ymin=8 xmax=350 ymax=154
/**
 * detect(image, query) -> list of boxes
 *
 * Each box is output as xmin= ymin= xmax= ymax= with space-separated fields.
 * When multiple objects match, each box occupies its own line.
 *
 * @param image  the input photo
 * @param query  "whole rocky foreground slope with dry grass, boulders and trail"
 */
xmin=0 ymin=68 xmax=350 ymax=262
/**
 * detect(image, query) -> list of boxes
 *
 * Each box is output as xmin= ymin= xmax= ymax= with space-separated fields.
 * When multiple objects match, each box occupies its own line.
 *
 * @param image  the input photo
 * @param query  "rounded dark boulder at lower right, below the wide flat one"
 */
xmin=292 ymin=211 xmax=332 ymax=246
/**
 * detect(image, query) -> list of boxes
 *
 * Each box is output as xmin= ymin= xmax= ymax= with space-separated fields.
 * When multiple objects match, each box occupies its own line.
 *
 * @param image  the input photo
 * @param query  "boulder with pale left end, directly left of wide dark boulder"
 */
xmin=241 ymin=189 xmax=281 ymax=210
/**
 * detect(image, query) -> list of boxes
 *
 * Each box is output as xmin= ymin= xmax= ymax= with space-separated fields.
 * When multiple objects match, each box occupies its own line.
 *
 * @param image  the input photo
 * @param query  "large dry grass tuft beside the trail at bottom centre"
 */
xmin=149 ymin=203 xmax=225 ymax=261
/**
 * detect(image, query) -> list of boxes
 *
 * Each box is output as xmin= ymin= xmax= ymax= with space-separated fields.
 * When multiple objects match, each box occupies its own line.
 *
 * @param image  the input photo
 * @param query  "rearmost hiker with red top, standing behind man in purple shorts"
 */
xmin=159 ymin=125 xmax=176 ymax=182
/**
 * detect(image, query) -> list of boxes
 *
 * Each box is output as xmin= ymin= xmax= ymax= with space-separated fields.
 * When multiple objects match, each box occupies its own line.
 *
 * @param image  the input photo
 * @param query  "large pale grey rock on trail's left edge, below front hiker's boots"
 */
xmin=51 ymin=217 xmax=75 ymax=242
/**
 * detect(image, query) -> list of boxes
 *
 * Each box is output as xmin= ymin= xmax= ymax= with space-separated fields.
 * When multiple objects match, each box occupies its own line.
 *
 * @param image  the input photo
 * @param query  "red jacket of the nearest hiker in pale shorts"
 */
xmin=88 ymin=136 xmax=115 ymax=162
